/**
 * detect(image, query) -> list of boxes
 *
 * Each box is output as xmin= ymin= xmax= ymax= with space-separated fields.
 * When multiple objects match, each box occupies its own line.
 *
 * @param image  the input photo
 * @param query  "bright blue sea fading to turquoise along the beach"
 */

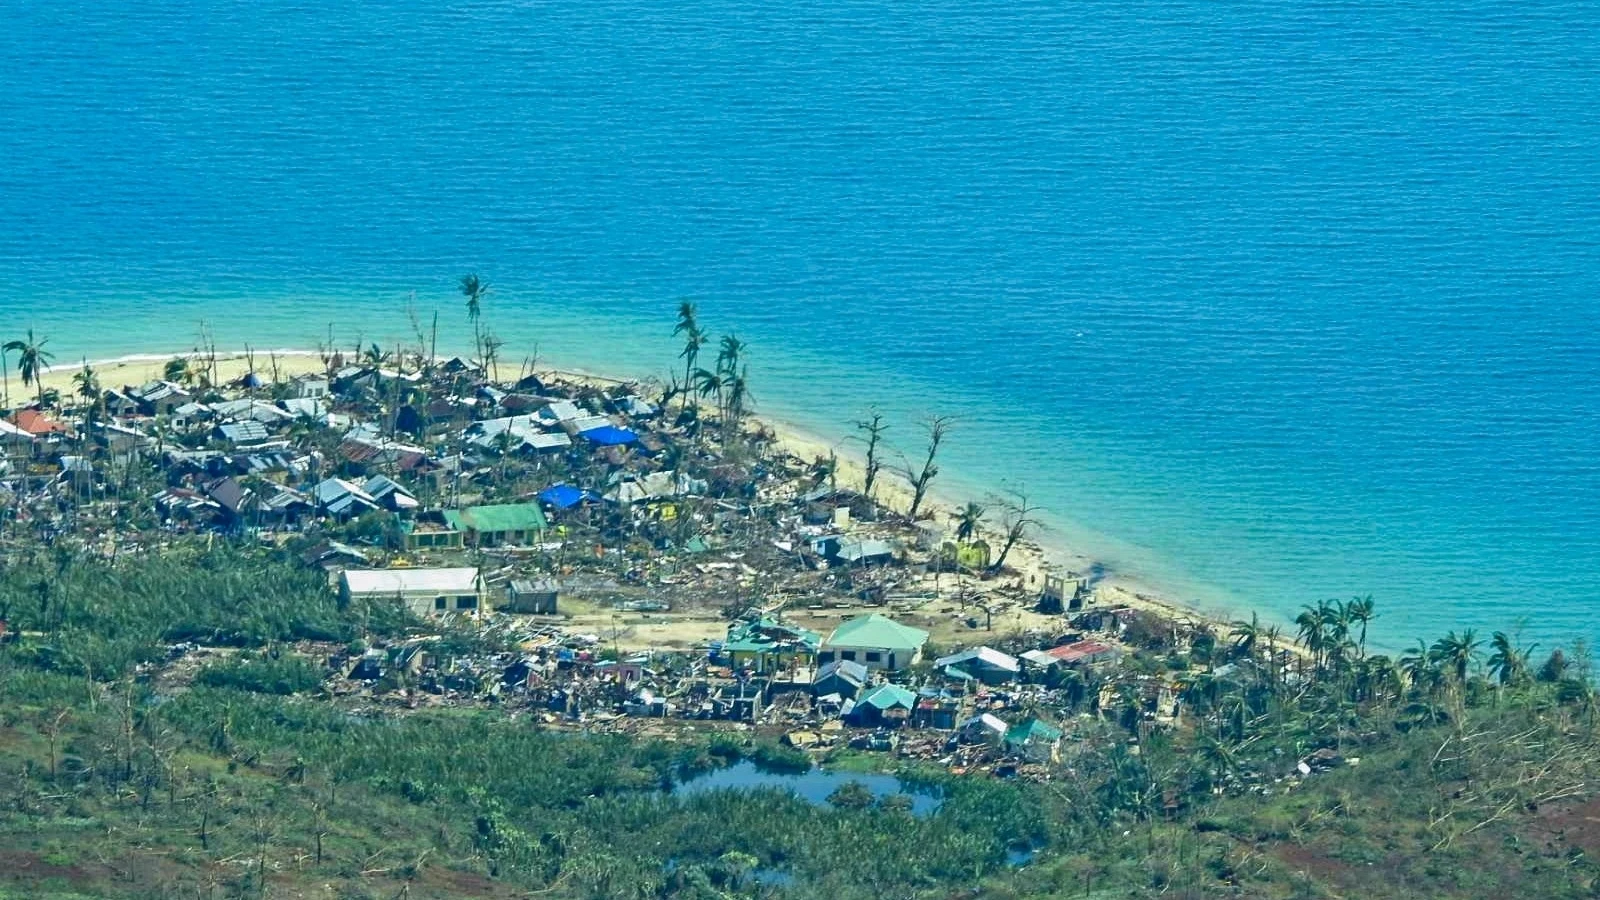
xmin=0 ymin=0 xmax=1600 ymax=649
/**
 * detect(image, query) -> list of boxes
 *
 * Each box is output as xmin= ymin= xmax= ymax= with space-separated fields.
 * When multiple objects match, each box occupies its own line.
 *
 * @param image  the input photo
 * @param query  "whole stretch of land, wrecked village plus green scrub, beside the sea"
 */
xmin=0 ymin=321 xmax=1600 ymax=900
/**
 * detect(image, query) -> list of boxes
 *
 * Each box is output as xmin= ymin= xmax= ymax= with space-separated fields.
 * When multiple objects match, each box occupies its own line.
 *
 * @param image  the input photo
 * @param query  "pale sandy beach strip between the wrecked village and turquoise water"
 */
xmin=10 ymin=349 xmax=1232 ymax=634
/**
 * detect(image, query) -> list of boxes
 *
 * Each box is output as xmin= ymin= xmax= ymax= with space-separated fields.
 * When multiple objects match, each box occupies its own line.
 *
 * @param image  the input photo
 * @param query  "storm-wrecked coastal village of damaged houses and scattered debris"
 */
xmin=0 ymin=331 xmax=1248 ymax=778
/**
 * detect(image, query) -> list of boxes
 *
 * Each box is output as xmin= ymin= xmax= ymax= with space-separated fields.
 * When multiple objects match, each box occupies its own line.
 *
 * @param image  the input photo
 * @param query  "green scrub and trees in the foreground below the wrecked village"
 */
xmin=0 ymin=546 xmax=1600 ymax=898
